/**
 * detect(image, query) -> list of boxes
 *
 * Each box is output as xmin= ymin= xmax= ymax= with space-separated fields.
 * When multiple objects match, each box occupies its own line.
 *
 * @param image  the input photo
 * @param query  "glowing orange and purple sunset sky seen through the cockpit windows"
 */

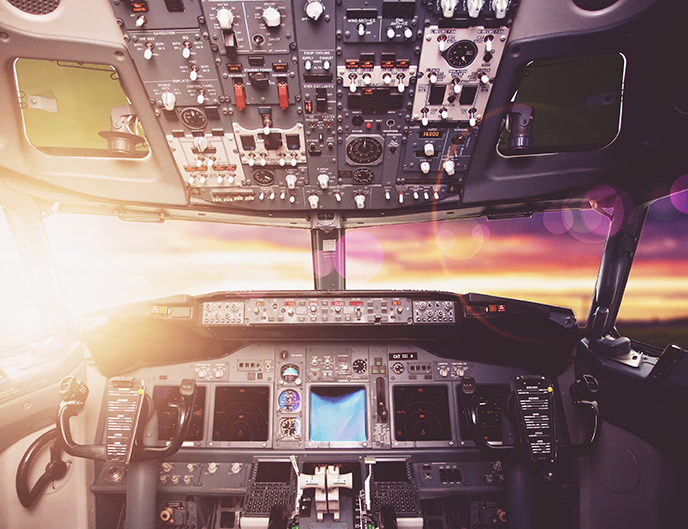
xmin=0 ymin=191 xmax=688 ymax=350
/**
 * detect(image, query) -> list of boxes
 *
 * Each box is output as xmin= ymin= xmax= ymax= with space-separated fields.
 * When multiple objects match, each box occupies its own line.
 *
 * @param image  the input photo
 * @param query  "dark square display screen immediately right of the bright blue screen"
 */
xmin=394 ymin=385 xmax=451 ymax=441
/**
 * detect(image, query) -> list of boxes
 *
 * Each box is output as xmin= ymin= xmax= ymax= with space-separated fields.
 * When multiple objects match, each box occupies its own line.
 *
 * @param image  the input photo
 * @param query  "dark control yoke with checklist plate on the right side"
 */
xmin=461 ymin=375 xmax=600 ymax=463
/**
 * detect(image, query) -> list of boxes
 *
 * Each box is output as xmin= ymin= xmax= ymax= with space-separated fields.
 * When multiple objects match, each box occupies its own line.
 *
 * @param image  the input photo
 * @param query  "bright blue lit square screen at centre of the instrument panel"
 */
xmin=310 ymin=386 xmax=367 ymax=443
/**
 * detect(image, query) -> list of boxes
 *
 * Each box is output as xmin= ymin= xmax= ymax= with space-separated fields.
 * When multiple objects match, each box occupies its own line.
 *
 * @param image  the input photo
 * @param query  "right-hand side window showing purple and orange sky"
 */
xmin=617 ymin=192 xmax=688 ymax=349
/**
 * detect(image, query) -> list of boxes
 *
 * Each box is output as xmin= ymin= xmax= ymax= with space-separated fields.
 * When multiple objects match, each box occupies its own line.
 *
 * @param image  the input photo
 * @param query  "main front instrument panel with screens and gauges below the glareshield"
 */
xmin=138 ymin=342 xmax=518 ymax=450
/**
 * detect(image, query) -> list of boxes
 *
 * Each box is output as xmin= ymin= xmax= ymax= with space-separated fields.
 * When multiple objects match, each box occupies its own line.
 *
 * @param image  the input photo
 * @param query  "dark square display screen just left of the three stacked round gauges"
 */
xmin=213 ymin=386 xmax=270 ymax=441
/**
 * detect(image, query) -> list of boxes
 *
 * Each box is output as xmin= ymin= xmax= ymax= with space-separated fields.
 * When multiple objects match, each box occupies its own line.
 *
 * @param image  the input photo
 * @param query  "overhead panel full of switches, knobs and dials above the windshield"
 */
xmin=111 ymin=0 xmax=517 ymax=216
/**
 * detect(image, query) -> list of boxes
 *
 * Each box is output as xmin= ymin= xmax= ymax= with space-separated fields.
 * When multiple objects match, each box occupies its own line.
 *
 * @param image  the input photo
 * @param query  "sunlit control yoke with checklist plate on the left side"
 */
xmin=57 ymin=376 xmax=196 ymax=464
